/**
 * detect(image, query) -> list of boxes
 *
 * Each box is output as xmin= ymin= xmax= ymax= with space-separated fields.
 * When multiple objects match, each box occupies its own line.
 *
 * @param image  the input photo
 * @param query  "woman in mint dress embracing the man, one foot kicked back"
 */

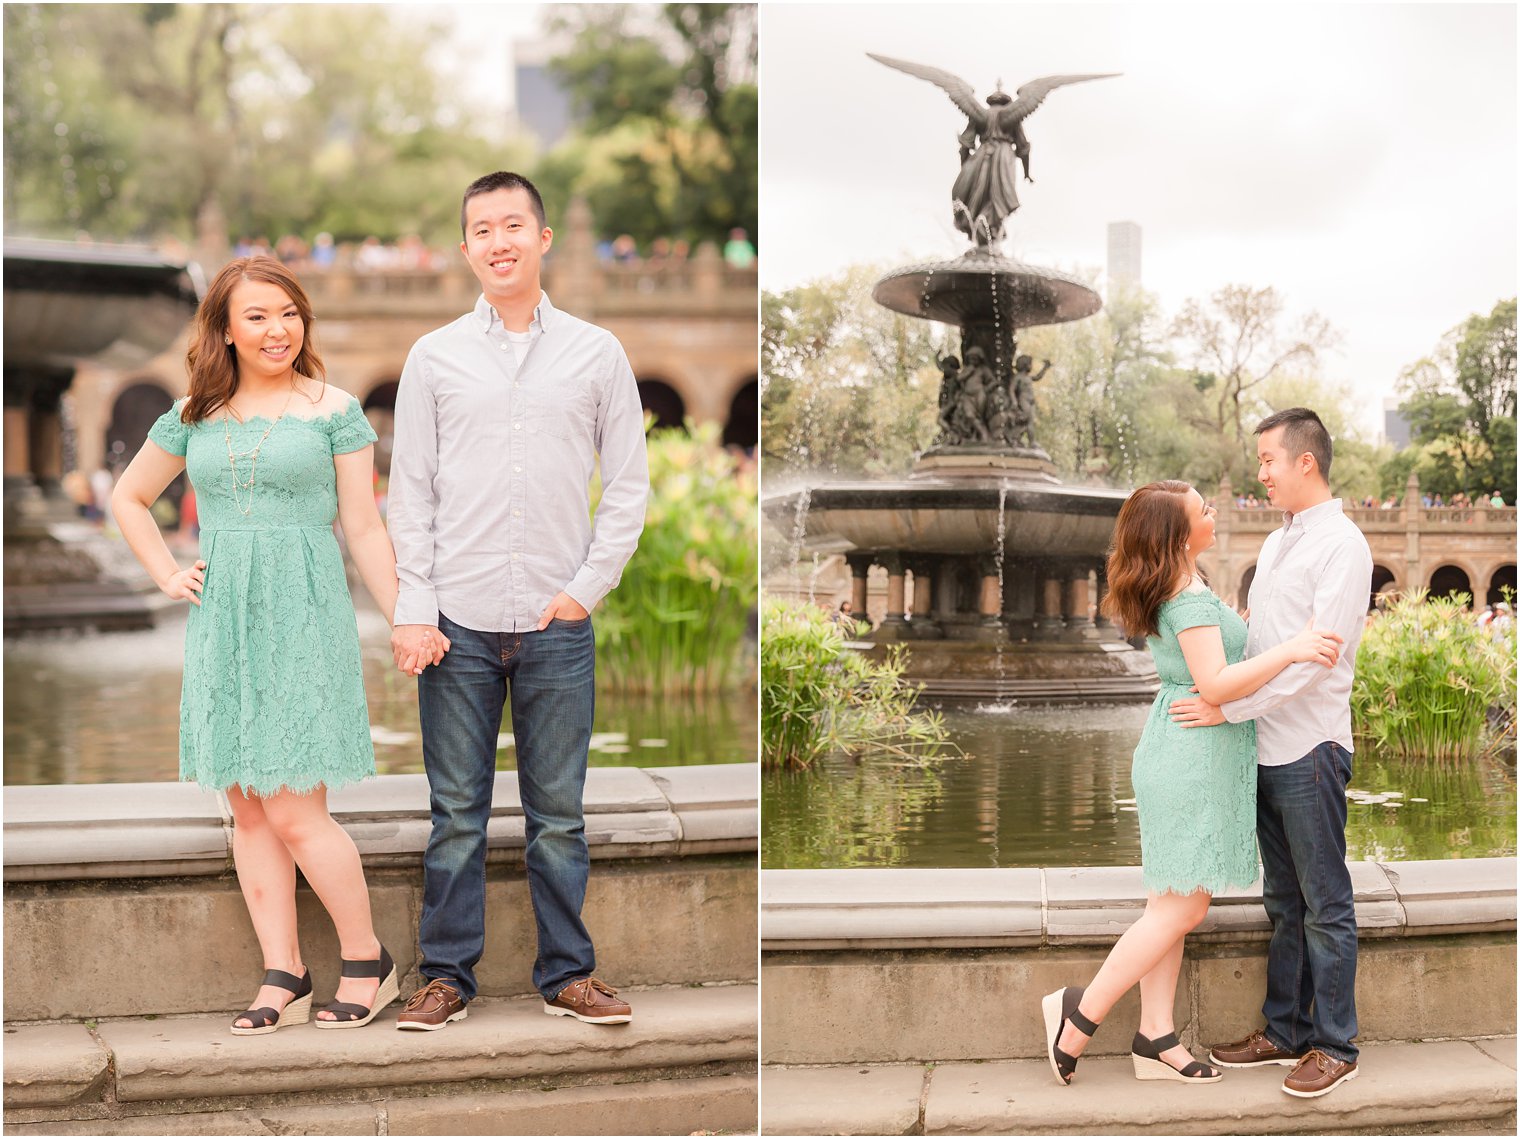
xmin=1041 ymin=482 xmax=1341 ymax=1084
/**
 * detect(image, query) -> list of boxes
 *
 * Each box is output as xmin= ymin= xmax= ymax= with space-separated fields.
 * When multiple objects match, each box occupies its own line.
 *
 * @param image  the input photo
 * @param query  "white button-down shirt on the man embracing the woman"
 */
xmin=1221 ymin=499 xmax=1373 ymax=766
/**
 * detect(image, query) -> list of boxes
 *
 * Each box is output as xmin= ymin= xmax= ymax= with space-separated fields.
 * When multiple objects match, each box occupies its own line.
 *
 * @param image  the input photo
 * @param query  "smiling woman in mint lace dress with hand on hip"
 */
xmin=111 ymin=257 xmax=447 ymax=1036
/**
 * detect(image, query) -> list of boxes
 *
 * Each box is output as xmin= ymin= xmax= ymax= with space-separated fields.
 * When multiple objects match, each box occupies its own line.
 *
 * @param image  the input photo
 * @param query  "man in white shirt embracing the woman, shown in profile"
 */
xmin=1172 ymin=408 xmax=1373 ymax=1098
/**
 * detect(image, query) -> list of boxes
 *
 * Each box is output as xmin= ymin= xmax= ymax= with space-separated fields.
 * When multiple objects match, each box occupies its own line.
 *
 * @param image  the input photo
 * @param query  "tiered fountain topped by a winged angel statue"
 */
xmin=766 ymin=55 xmax=1157 ymax=700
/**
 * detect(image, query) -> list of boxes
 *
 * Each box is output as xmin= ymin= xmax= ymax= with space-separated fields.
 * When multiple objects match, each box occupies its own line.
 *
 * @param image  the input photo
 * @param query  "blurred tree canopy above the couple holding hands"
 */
xmin=5 ymin=3 xmax=758 ymax=245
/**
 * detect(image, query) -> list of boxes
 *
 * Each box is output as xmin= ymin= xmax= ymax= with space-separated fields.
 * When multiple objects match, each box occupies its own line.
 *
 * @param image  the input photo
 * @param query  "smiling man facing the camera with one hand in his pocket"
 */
xmin=389 ymin=172 xmax=649 ymax=1030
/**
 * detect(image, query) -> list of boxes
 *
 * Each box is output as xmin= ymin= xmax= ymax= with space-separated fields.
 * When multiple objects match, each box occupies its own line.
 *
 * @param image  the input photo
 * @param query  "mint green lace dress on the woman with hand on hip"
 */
xmin=147 ymin=398 xmax=375 ymax=795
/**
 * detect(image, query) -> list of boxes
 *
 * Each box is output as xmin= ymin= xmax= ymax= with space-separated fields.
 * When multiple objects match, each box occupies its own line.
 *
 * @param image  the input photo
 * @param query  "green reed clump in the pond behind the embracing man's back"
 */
xmin=1351 ymin=590 xmax=1515 ymax=759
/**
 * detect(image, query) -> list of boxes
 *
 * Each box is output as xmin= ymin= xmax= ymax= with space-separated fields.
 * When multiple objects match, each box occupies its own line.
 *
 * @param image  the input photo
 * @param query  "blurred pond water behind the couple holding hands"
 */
xmin=5 ymin=610 xmax=757 ymax=783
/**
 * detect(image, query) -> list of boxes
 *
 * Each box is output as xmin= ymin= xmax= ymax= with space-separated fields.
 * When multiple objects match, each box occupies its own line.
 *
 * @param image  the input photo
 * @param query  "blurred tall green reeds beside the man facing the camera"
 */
xmin=596 ymin=421 xmax=760 ymax=700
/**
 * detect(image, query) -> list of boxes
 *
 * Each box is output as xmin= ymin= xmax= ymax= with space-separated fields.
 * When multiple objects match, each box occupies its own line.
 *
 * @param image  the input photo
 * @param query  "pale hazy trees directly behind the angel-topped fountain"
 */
xmin=760 ymin=266 xmax=1404 ymax=499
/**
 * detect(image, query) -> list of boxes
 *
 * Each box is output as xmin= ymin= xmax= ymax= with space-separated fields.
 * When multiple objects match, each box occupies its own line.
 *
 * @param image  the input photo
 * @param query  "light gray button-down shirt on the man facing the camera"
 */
xmin=389 ymin=295 xmax=649 ymax=633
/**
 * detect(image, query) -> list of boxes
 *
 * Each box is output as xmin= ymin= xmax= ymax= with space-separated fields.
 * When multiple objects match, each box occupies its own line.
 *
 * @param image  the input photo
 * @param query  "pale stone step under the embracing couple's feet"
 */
xmin=762 ymin=1037 xmax=1515 ymax=1136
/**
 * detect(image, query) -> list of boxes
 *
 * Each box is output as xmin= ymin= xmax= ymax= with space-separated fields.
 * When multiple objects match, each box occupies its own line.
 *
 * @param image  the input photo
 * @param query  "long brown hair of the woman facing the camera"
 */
xmin=179 ymin=255 xmax=327 ymax=423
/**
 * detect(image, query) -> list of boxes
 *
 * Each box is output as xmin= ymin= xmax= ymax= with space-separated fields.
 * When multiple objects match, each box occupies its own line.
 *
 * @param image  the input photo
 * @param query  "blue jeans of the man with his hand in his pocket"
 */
xmin=416 ymin=614 xmax=596 ymax=1001
